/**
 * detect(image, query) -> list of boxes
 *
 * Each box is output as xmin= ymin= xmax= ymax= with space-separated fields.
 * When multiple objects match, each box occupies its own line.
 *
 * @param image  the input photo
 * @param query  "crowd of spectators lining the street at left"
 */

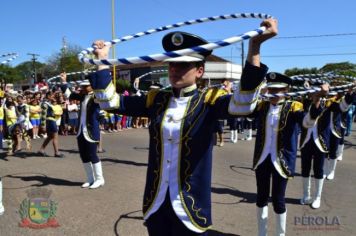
xmin=0 ymin=85 xmax=149 ymax=154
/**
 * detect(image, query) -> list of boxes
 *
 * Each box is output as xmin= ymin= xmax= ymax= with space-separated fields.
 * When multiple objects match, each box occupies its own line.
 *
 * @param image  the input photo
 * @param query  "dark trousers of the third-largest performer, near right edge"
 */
xmin=301 ymin=138 xmax=326 ymax=179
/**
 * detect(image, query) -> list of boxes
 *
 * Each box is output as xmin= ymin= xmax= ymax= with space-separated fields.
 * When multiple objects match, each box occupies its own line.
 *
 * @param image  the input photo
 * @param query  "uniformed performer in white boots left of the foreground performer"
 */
xmin=60 ymin=73 xmax=105 ymax=189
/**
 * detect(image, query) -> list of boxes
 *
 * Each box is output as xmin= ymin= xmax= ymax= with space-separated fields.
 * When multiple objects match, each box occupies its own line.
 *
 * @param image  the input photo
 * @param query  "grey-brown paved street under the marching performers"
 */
xmin=0 ymin=129 xmax=356 ymax=236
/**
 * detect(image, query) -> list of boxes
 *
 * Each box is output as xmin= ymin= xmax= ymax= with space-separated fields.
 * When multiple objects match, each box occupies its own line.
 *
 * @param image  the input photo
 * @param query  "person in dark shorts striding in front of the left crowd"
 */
xmin=37 ymin=93 xmax=64 ymax=158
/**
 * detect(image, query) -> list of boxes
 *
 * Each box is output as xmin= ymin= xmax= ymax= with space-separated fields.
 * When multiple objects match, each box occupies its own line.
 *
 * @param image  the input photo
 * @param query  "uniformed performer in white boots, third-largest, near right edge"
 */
xmin=300 ymin=86 xmax=354 ymax=209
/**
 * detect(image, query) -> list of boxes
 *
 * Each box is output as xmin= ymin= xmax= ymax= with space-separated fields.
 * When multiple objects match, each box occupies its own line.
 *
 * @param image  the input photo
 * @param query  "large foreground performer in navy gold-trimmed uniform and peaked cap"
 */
xmin=90 ymin=19 xmax=277 ymax=236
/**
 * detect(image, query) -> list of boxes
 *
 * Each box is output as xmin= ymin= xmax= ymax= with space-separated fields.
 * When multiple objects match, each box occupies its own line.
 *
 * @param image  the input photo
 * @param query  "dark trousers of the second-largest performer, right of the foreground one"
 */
xmin=255 ymin=155 xmax=288 ymax=214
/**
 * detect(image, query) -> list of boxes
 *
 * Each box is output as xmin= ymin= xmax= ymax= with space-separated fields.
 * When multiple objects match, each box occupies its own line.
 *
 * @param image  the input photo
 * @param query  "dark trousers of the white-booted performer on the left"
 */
xmin=77 ymin=133 xmax=100 ymax=164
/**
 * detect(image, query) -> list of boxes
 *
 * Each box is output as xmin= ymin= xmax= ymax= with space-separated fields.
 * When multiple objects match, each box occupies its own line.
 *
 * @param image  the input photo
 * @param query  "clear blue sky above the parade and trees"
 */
xmin=0 ymin=0 xmax=356 ymax=72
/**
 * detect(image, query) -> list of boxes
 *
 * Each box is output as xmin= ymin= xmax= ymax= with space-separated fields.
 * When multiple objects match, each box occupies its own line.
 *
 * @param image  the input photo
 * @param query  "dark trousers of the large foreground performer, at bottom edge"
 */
xmin=146 ymin=191 xmax=208 ymax=236
